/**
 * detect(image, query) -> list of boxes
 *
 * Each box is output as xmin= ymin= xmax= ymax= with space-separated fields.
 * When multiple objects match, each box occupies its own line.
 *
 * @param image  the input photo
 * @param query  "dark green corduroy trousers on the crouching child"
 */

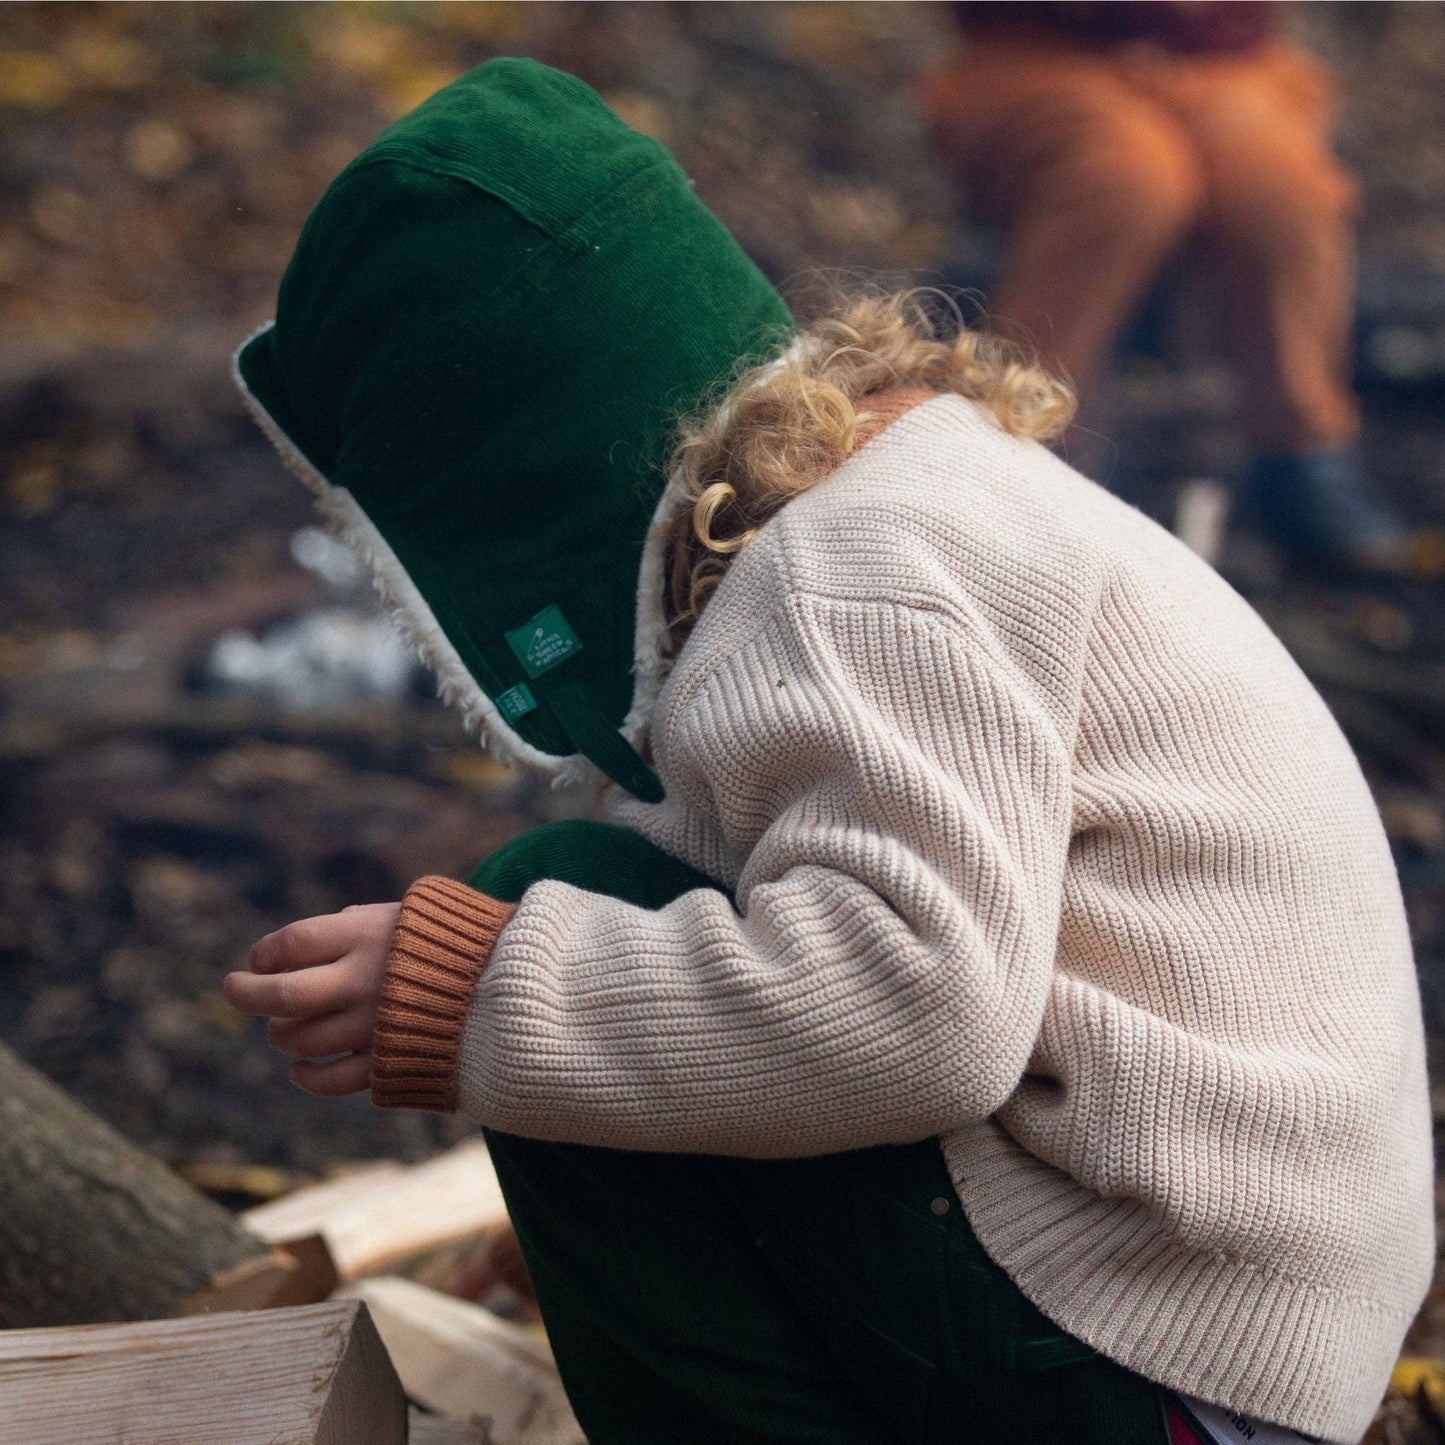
xmin=471 ymin=824 xmax=1169 ymax=1445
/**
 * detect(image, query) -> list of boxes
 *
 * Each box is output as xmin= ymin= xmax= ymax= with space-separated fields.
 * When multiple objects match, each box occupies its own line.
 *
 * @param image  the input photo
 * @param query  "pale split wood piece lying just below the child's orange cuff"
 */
xmin=241 ymin=1139 xmax=507 ymax=1280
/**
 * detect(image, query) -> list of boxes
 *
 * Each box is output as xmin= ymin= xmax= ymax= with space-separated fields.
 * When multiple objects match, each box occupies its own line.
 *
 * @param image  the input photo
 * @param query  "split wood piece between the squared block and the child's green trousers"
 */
xmin=345 ymin=1277 xmax=582 ymax=1445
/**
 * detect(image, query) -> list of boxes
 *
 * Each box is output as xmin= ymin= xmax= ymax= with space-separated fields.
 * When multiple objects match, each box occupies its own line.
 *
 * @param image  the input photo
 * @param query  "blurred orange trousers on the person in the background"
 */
xmin=923 ymin=35 xmax=1358 ymax=452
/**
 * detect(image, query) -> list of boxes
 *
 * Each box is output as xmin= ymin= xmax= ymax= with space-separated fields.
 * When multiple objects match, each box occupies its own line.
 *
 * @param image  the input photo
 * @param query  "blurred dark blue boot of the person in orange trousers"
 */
xmin=1248 ymin=448 xmax=1445 ymax=578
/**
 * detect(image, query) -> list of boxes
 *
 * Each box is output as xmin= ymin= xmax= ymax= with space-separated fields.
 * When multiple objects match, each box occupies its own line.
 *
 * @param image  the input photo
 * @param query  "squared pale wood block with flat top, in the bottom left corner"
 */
xmin=0 ymin=1301 xmax=406 ymax=1445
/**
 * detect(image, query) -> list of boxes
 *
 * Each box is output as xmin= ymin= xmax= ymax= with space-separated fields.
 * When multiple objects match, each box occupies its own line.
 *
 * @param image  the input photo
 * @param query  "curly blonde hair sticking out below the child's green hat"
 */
xmin=665 ymin=290 xmax=1075 ymax=652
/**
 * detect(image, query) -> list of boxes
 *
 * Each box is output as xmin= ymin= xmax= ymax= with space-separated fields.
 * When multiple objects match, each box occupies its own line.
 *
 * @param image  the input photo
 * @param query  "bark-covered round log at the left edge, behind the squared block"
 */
xmin=0 ymin=1045 xmax=295 ymax=1329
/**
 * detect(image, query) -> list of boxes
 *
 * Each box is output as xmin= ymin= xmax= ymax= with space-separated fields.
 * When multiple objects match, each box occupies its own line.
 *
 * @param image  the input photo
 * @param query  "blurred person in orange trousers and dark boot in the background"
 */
xmin=922 ymin=0 xmax=1433 ymax=575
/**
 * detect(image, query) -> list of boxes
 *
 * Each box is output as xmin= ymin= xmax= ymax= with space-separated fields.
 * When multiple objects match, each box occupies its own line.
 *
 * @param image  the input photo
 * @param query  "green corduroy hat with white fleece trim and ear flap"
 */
xmin=236 ymin=59 xmax=792 ymax=801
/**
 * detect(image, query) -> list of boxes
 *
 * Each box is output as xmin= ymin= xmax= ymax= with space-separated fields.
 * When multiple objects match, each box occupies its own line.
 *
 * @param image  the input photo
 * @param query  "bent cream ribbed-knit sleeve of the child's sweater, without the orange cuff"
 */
xmin=450 ymin=562 xmax=1069 ymax=1157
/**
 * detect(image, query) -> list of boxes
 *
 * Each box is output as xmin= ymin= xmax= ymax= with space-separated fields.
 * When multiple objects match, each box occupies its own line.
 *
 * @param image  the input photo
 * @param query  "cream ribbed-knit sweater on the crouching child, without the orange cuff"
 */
xmin=460 ymin=396 xmax=1433 ymax=1441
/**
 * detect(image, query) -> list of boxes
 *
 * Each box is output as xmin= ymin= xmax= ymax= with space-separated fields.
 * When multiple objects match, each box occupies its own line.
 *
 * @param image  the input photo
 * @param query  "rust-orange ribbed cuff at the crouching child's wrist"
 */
xmin=371 ymin=877 xmax=516 ymax=1114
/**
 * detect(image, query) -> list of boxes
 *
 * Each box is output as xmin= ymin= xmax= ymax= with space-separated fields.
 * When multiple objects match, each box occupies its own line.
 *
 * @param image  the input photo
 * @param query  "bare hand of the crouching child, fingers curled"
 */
xmin=221 ymin=903 xmax=402 ymax=1097
